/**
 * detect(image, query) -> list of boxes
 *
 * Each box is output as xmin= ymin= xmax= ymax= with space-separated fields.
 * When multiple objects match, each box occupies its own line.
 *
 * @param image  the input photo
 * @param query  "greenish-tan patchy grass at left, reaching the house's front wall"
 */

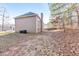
xmin=0 ymin=32 xmax=37 ymax=52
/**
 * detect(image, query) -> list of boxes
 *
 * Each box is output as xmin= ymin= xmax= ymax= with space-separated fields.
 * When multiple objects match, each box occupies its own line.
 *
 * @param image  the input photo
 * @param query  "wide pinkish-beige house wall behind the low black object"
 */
xmin=15 ymin=16 xmax=36 ymax=32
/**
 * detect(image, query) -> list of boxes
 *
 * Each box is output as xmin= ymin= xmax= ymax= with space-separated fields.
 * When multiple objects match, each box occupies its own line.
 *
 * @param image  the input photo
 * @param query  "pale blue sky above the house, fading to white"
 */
xmin=0 ymin=3 xmax=50 ymax=24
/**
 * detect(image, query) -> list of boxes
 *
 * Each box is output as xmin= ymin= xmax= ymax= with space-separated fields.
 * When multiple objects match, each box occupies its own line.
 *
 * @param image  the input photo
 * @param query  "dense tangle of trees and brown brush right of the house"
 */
xmin=49 ymin=3 xmax=79 ymax=31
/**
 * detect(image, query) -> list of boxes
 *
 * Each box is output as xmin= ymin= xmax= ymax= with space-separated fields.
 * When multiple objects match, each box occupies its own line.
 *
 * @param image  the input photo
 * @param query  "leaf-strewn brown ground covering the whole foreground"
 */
xmin=0 ymin=31 xmax=79 ymax=56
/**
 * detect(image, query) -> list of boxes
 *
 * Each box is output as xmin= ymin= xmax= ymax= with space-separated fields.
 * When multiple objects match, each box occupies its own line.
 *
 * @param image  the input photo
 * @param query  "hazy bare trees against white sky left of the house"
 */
xmin=0 ymin=7 xmax=14 ymax=31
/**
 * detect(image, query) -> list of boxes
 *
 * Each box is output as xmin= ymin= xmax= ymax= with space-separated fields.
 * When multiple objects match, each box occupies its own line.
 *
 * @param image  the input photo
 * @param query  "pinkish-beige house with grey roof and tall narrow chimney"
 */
xmin=15 ymin=12 xmax=43 ymax=33
